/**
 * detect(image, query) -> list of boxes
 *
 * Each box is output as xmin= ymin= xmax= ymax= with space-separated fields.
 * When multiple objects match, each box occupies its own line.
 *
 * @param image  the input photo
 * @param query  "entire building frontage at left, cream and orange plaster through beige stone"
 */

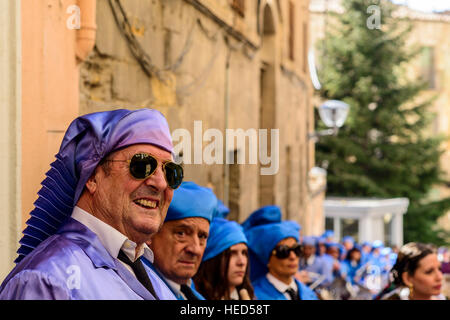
xmin=0 ymin=0 xmax=325 ymax=278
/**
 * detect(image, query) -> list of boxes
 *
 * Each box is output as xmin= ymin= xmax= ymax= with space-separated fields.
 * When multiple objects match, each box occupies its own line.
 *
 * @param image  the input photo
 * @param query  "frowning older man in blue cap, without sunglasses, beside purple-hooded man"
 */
xmin=144 ymin=181 xmax=217 ymax=300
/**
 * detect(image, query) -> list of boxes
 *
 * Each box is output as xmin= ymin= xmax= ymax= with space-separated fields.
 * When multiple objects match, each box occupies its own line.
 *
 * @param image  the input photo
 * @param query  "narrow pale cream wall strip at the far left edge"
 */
xmin=0 ymin=1 xmax=21 ymax=279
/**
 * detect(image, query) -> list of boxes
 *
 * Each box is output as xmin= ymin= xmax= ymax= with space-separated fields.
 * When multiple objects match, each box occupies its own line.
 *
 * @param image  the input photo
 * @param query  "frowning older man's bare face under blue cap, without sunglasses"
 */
xmin=150 ymin=217 xmax=209 ymax=284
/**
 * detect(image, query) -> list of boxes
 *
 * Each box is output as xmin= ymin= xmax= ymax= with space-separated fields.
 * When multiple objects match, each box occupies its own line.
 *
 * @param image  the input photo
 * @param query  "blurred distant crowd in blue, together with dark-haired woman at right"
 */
xmin=297 ymin=230 xmax=445 ymax=300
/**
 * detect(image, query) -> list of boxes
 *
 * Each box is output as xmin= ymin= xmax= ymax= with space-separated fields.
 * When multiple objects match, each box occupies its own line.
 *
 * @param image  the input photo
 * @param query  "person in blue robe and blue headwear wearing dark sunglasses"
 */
xmin=243 ymin=206 xmax=318 ymax=300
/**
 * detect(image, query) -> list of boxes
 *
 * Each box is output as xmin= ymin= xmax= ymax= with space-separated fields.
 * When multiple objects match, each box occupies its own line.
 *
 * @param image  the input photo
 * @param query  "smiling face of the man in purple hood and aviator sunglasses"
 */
xmin=86 ymin=144 xmax=173 ymax=244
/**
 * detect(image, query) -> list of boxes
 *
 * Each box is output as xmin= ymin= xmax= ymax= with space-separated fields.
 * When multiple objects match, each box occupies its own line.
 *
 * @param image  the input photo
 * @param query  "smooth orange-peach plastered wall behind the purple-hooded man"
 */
xmin=21 ymin=0 xmax=91 ymax=228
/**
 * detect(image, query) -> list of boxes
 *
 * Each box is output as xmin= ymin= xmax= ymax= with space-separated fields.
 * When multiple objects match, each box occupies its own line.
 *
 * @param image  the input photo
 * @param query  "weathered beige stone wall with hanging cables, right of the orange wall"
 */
xmin=80 ymin=0 xmax=314 ymax=225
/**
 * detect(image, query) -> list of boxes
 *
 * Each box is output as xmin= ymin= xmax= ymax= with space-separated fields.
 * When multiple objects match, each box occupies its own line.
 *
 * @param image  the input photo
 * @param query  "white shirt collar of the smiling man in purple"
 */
xmin=72 ymin=206 xmax=153 ymax=263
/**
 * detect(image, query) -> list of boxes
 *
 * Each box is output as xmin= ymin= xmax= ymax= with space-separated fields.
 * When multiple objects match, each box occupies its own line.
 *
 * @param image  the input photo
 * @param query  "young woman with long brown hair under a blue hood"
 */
xmin=194 ymin=217 xmax=254 ymax=300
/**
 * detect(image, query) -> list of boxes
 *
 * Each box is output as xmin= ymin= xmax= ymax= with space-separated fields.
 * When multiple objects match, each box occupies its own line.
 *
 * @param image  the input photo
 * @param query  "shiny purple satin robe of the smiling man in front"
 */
xmin=0 ymin=218 xmax=176 ymax=300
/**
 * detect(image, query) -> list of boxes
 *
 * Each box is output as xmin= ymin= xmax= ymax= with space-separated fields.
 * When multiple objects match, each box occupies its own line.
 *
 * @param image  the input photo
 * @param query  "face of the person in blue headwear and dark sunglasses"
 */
xmin=267 ymin=238 xmax=300 ymax=281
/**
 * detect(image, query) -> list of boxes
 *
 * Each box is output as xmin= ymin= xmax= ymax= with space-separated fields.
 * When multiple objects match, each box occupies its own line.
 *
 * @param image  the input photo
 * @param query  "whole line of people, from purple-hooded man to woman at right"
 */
xmin=0 ymin=109 xmax=443 ymax=300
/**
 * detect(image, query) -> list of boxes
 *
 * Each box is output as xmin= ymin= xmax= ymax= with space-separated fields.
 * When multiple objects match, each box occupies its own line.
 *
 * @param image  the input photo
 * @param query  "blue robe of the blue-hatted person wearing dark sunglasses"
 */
xmin=252 ymin=276 xmax=318 ymax=300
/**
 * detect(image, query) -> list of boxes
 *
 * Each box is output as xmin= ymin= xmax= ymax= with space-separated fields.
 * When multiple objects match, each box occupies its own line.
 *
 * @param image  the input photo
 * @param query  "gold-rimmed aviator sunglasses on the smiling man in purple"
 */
xmin=106 ymin=152 xmax=183 ymax=189
